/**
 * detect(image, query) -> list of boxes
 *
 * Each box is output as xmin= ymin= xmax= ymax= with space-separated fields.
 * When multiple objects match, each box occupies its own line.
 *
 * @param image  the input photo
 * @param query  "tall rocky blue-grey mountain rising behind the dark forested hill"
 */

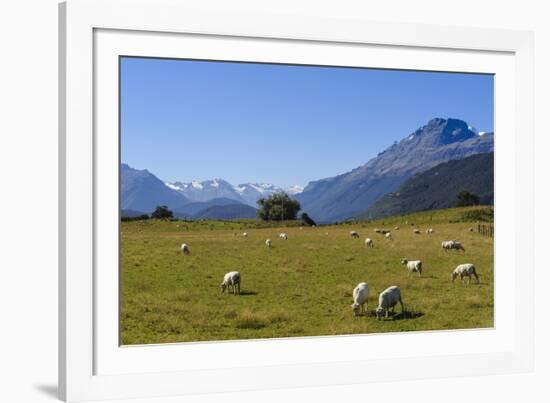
xmin=296 ymin=118 xmax=494 ymax=222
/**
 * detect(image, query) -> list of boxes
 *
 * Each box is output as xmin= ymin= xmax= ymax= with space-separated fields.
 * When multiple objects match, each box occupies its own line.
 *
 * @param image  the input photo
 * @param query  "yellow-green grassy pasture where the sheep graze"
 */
xmin=121 ymin=208 xmax=494 ymax=345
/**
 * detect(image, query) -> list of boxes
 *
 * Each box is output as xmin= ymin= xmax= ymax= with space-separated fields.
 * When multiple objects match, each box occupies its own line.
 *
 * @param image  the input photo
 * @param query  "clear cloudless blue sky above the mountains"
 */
xmin=121 ymin=58 xmax=494 ymax=186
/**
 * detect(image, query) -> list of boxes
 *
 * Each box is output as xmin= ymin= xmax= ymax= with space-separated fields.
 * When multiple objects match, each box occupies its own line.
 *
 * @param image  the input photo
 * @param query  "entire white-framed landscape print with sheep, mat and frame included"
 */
xmin=59 ymin=0 xmax=534 ymax=401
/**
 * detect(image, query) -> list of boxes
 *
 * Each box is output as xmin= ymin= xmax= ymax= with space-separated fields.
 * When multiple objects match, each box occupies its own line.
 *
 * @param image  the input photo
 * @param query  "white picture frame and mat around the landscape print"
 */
xmin=59 ymin=0 xmax=534 ymax=401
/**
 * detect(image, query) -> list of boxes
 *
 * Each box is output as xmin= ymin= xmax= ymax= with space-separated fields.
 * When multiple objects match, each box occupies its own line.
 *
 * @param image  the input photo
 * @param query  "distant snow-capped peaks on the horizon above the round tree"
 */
xmin=165 ymin=179 xmax=303 ymax=207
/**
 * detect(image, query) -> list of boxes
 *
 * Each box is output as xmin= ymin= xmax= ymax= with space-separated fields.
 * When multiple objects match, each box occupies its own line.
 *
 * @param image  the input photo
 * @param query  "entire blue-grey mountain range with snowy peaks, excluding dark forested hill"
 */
xmin=121 ymin=118 xmax=494 ymax=223
